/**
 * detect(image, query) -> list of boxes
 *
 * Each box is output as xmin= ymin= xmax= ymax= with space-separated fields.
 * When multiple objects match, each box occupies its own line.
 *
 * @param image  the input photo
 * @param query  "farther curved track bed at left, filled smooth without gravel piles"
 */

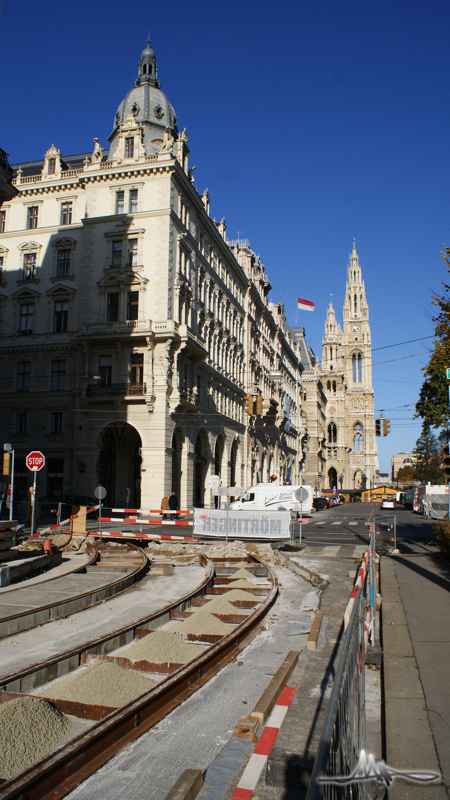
xmin=0 ymin=542 xmax=149 ymax=639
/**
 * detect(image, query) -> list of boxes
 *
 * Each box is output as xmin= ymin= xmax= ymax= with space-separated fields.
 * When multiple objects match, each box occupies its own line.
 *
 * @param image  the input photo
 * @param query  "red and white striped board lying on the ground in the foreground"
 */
xmin=231 ymin=686 xmax=295 ymax=800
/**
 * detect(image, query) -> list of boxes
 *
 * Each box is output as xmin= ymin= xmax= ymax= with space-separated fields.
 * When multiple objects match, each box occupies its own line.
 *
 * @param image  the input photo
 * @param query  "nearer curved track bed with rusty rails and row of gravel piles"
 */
xmin=0 ymin=556 xmax=278 ymax=800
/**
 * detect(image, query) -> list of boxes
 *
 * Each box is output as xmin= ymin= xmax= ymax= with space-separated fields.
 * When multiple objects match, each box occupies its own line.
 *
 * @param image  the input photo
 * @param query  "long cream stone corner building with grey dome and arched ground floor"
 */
xmin=0 ymin=42 xmax=310 ymax=508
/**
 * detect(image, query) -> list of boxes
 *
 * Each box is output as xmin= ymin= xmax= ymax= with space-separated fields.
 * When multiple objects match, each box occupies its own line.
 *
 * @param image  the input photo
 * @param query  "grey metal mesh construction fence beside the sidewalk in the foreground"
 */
xmin=306 ymin=587 xmax=365 ymax=800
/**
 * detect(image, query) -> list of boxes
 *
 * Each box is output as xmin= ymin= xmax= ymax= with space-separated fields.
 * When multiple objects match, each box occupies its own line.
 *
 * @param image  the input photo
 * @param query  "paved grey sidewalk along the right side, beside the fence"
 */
xmin=380 ymin=543 xmax=450 ymax=800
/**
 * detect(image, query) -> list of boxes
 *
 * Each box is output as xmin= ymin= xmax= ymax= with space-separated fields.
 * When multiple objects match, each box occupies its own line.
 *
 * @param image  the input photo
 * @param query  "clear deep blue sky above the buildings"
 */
xmin=0 ymin=0 xmax=450 ymax=472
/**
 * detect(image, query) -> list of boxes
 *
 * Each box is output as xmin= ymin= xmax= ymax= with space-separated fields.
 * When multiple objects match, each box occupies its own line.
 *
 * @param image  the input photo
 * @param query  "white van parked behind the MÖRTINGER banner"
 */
xmin=230 ymin=483 xmax=313 ymax=514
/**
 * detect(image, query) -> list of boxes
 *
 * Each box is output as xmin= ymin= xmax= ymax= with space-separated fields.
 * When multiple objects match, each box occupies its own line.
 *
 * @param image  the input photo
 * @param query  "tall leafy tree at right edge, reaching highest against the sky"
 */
xmin=416 ymin=245 xmax=450 ymax=430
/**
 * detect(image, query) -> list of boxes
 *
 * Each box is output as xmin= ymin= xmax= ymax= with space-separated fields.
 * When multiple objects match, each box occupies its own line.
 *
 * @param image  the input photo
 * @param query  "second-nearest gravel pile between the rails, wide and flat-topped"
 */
xmin=40 ymin=661 xmax=156 ymax=708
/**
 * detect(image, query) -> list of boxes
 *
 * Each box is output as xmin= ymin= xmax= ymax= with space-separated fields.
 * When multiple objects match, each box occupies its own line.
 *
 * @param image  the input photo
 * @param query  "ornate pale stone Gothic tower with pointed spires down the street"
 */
xmin=322 ymin=239 xmax=377 ymax=492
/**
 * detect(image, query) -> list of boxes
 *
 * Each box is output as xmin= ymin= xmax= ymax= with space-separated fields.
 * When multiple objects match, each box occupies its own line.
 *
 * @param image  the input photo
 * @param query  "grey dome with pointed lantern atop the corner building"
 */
xmin=109 ymin=39 xmax=178 ymax=160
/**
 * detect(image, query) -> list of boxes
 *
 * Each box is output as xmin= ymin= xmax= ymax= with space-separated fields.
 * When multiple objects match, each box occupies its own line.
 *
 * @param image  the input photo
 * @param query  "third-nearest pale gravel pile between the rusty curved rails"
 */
xmin=119 ymin=630 xmax=206 ymax=664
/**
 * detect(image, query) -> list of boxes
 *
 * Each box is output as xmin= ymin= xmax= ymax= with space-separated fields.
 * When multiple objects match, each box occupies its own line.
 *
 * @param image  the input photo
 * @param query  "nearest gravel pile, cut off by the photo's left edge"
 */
xmin=0 ymin=697 xmax=74 ymax=780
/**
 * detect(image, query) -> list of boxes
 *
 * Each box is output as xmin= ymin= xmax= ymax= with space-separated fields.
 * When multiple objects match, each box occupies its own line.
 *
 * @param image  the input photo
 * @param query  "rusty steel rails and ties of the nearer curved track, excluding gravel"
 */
xmin=0 ymin=556 xmax=278 ymax=800
